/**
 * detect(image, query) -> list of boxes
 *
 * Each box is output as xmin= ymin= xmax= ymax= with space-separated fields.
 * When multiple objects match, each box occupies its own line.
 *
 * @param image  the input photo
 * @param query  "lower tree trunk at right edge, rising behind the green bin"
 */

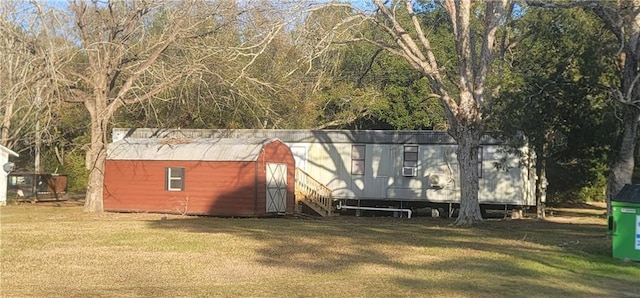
xmin=607 ymin=107 xmax=640 ymax=214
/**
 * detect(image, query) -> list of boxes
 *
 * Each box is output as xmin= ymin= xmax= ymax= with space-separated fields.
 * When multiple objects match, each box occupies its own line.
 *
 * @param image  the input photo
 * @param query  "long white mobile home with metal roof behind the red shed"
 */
xmin=113 ymin=128 xmax=535 ymax=213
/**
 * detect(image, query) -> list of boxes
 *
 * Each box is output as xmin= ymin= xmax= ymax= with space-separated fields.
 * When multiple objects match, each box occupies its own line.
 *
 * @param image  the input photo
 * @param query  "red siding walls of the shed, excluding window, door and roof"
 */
xmin=103 ymin=141 xmax=295 ymax=216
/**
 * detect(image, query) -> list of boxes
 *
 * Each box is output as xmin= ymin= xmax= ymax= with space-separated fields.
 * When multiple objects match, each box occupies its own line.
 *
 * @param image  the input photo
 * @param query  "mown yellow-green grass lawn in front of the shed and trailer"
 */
xmin=0 ymin=204 xmax=640 ymax=297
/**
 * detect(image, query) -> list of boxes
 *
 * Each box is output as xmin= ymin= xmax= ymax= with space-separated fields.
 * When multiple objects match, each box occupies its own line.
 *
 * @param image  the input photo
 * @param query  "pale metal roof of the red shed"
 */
xmin=107 ymin=137 xmax=276 ymax=161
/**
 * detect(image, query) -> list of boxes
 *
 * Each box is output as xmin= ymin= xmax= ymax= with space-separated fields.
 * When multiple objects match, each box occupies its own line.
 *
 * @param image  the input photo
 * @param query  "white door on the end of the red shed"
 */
xmin=267 ymin=163 xmax=287 ymax=212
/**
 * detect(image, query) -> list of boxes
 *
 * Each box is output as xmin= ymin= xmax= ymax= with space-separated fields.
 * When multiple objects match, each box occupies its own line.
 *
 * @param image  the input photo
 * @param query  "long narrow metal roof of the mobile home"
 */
xmin=113 ymin=128 xmax=501 ymax=145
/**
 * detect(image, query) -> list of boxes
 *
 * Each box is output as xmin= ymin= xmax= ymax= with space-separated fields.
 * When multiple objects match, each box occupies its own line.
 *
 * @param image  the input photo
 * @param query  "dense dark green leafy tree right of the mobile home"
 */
xmin=488 ymin=9 xmax=617 ymax=201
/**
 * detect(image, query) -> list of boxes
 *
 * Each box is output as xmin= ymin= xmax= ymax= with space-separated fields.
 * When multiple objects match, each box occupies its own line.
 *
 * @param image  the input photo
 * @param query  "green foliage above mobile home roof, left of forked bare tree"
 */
xmin=330 ymin=44 xmax=445 ymax=129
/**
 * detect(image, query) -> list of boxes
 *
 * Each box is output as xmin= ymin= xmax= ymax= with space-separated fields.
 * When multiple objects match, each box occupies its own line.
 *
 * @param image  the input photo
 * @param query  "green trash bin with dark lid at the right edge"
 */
xmin=609 ymin=184 xmax=640 ymax=261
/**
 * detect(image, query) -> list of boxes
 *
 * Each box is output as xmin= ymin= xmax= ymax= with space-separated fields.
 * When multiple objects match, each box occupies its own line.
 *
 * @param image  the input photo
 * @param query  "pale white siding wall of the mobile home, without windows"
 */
xmin=296 ymin=143 xmax=535 ymax=206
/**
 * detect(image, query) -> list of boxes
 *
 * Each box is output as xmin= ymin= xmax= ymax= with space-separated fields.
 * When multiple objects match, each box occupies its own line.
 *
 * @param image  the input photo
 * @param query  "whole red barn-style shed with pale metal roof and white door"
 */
xmin=103 ymin=138 xmax=295 ymax=216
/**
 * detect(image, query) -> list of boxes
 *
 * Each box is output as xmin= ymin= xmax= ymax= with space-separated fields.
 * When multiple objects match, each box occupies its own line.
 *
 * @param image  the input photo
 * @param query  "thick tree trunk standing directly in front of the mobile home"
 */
xmin=454 ymin=126 xmax=482 ymax=226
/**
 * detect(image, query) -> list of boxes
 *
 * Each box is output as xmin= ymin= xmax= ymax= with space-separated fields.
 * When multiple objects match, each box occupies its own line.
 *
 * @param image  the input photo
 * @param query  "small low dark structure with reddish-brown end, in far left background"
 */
xmin=7 ymin=172 xmax=68 ymax=201
